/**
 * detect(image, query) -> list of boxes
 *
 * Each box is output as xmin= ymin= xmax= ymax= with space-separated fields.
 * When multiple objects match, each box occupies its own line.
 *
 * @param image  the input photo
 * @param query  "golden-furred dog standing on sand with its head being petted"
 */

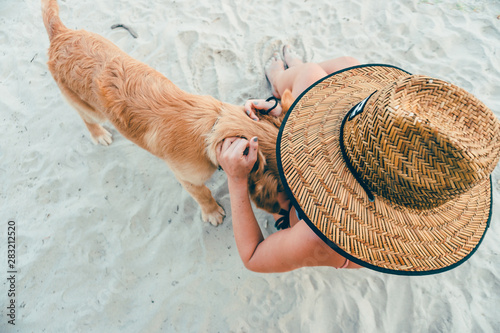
xmin=42 ymin=0 xmax=291 ymax=225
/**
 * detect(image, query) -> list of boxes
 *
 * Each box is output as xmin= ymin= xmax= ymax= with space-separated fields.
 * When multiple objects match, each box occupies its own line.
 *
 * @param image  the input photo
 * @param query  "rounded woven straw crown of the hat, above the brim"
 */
xmin=343 ymin=75 xmax=500 ymax=210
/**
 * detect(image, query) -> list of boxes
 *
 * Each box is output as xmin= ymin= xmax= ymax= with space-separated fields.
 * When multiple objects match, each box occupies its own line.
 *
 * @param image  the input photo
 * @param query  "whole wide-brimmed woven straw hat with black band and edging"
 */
xmin=277 ymin=65 xmax=500 ymax=275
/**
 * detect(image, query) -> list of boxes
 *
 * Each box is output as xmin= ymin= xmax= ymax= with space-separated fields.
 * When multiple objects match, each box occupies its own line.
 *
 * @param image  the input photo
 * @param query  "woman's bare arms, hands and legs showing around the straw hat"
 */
xmin=218 ymin=46 xmax=360 ymax=272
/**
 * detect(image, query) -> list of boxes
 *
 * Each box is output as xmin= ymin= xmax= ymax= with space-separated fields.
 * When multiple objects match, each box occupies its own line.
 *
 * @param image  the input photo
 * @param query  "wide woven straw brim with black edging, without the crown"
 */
xmin=276 ymin=64 xmax=492 ymax=275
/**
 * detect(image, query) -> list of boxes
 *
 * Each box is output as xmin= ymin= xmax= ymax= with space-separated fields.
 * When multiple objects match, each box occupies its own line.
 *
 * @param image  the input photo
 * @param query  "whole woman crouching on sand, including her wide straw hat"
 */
xmin=217 ymin=47 xmax=500 ymax=275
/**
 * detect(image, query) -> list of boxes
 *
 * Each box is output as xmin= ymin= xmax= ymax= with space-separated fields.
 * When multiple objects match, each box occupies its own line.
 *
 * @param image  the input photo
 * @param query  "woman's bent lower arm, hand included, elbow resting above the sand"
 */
xmin=217 ymin=138 xmax=342 ymax=272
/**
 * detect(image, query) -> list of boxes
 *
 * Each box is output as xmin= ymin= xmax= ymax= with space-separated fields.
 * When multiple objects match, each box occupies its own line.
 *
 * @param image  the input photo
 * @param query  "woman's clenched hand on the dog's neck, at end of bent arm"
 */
xmin=216 ymin=137 xmax=259 ymax=183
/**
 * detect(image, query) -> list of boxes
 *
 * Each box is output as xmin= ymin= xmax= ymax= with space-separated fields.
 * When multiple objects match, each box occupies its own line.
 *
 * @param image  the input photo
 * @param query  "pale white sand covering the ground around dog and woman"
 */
xmin=0 ymin=0 xmax=500 ymax=332
